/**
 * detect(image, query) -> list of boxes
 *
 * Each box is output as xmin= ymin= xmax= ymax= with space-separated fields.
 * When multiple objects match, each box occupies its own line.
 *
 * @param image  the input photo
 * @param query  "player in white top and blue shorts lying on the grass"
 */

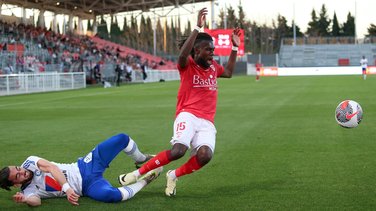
xmin=0 ymin=134 xmax=163 ymax=206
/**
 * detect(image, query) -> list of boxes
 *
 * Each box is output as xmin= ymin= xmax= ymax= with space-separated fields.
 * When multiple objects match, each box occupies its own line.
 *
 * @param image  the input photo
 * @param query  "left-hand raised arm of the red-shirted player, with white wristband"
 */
xmin=178 ymin=8 xmax=208 ymax=68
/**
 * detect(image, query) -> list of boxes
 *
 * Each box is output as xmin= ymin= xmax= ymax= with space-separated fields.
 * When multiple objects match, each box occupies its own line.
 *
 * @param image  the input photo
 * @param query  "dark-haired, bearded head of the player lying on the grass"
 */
xmin=0 ymin=166 xmax=34 ymax=190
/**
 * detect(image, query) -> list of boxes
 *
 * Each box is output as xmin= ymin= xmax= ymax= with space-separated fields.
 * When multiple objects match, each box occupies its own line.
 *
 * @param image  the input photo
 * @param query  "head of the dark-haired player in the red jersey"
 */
xmin=179 ymin=32 xmax=214 ymax=68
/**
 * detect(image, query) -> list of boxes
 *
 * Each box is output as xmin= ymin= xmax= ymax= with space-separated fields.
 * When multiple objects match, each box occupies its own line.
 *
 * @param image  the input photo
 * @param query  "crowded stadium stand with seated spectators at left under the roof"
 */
xmin=0 ymin=21 xmax=176 ymax=83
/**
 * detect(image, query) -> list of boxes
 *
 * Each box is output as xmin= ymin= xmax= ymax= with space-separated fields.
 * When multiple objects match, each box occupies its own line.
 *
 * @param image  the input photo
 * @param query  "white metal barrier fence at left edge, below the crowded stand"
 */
xmin=0 ymin=72 xmax=86 ymax=96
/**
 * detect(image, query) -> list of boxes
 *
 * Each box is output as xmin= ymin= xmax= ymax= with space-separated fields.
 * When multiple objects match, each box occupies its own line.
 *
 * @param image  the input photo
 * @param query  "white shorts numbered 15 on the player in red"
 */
xmin=170 ymin=112 xmax=217 ymax=154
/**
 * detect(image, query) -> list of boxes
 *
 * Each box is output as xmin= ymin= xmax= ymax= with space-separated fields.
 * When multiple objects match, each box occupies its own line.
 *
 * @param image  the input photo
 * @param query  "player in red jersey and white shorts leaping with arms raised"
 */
xmin=119 ymin=8 xmax=240 ymax=196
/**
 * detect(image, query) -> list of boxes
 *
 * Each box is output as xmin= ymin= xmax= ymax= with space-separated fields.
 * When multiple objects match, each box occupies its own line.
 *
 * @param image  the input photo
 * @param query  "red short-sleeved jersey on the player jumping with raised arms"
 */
xmin=176 ymin=56 xmax=224 ymax=123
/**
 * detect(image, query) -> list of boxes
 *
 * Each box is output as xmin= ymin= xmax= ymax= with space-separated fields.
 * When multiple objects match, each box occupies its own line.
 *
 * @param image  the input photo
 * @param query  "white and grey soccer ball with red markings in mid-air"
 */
xmin=335 ymin=100 xmax=363 ymax=128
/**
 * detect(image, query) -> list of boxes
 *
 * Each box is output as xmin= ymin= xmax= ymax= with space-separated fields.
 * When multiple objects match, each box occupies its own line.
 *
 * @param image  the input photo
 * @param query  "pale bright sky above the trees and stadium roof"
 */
xmin=2 ymin=0 xmax=376 ymax=38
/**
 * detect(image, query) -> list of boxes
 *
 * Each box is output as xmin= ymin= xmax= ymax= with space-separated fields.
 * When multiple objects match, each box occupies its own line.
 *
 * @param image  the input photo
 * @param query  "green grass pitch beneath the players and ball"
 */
xmin=0 ymin=76 xmax=376 ymax=210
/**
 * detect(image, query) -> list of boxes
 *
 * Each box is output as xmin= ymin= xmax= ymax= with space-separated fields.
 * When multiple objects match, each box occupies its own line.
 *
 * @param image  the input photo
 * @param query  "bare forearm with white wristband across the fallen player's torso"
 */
xmin=38 ymin=159 xmax=80 ymax=205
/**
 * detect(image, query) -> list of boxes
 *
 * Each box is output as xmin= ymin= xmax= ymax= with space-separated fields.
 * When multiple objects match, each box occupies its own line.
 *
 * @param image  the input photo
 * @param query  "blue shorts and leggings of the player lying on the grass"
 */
xmin=78 ymin=134 xmax=129 ymax=202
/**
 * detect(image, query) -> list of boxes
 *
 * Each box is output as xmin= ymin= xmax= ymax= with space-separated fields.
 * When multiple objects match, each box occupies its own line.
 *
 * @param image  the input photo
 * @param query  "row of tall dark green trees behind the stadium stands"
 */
xmin=92 ymin=4 xmax=376 ymax=56
